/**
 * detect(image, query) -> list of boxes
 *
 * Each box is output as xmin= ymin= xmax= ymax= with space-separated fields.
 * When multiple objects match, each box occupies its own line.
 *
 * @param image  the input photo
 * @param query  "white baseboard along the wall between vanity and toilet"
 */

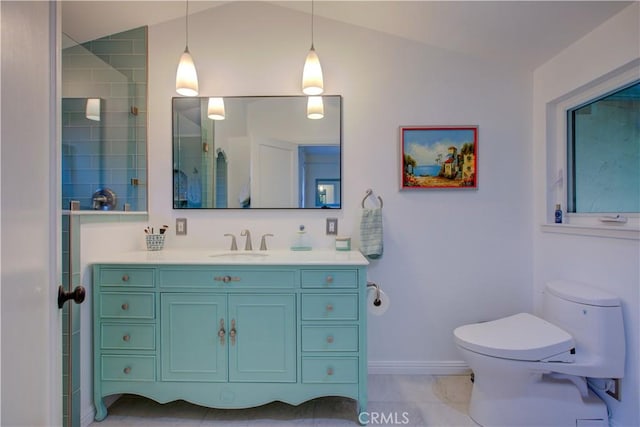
xmin=368 ymin=360 xmax=471 ymax=375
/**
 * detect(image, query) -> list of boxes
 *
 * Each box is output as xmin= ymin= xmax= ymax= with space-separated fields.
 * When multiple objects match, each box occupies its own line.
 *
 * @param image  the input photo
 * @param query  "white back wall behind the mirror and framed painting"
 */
xmin=82 ymin=2 xmax=533 ymax=424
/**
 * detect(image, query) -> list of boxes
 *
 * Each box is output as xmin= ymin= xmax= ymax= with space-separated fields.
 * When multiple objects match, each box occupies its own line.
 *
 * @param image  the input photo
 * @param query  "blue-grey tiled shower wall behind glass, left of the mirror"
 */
xmin=62 ymin=27 xmax=147 ymax=211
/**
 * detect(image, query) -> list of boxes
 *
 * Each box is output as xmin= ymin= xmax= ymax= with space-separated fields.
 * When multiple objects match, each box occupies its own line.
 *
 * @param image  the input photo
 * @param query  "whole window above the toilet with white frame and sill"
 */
xmin=541 ymin=58 xmax=640 ymax=240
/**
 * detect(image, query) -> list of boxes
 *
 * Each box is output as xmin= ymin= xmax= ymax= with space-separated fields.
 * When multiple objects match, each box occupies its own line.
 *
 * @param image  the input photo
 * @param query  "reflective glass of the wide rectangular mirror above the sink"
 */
xmin=173 ymin=95 xmax=342 ymax=209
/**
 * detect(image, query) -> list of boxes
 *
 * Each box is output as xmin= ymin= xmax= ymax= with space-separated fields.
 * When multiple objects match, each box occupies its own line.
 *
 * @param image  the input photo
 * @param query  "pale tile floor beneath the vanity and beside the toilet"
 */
xmin=90 ymin=375 xmax=476 ymax=427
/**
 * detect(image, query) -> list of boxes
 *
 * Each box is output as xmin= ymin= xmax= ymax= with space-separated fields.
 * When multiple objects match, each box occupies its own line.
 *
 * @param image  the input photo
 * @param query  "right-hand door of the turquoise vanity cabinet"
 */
xmin=229 ymin=294 xmax=296 ymax=382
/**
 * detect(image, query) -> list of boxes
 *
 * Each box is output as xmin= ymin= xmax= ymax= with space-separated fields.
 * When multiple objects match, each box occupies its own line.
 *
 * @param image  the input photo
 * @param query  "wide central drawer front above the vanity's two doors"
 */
xmin=159 ymin=268 xmax=296 ymax=289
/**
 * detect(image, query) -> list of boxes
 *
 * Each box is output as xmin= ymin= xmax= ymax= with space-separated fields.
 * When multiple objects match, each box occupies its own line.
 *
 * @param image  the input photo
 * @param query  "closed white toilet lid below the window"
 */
xmin=453 ymin=313 xmax=575 ymax=361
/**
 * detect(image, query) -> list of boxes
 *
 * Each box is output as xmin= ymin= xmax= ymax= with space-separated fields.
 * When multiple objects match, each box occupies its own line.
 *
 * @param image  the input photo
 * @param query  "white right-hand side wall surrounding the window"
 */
xmin=532 ymin=3 xmax=640 ymax=426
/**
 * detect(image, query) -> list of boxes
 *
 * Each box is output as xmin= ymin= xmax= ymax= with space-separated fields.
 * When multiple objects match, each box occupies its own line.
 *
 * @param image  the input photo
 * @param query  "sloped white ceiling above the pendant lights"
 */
xmin=62 ymin=0 xmax=633 ymax=70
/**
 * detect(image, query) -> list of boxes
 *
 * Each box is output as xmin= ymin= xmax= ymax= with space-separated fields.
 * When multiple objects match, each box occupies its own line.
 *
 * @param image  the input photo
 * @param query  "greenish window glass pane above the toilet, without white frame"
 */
xmin=567 ymin=81 xmax=640 ymax=214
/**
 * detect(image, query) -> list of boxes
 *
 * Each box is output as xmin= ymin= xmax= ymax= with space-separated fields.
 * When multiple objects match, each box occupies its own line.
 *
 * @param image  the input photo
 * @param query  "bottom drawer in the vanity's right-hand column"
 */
xmin=302 ymin=357 xmax=358 ymax=384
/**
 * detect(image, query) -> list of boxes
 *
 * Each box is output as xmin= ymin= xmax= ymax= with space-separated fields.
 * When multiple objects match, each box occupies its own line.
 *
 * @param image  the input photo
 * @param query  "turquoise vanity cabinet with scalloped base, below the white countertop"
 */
xmin=93 ymin=257 xmax=367 ymax=421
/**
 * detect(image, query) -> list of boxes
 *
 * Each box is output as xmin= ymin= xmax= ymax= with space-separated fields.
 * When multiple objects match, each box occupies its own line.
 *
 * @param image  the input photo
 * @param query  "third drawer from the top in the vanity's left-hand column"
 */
xmin=100 ymin=323 xmax=156 ymax=350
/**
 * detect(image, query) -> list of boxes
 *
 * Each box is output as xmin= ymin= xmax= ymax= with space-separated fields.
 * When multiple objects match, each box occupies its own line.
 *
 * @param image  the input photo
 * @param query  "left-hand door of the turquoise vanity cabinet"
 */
xmin=160 ymin=293 xmax=229 ymax=381
